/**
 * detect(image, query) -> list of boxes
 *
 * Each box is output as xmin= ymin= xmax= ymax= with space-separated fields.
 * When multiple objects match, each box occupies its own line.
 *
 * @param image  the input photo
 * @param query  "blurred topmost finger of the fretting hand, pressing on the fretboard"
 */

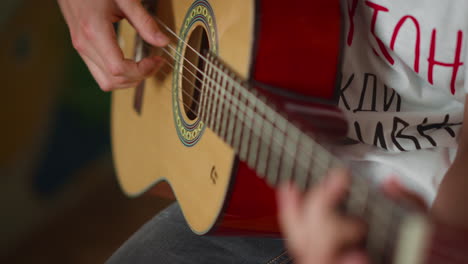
xmin=317 ymin=169 xmax=350 ymax=208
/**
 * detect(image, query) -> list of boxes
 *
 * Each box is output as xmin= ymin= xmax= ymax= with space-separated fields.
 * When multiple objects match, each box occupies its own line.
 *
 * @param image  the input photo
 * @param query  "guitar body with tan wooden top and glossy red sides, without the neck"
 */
xmin=112 ymin=0 xmax=341 ymax=235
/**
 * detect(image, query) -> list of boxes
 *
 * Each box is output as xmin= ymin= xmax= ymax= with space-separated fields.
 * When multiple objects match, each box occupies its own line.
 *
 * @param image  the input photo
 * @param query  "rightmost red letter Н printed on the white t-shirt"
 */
xmin=427 ymin=29 xmax=463 ymax=94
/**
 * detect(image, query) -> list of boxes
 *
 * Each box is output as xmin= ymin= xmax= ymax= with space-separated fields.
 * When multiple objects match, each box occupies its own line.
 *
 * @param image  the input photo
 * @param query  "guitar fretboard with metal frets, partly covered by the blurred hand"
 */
xmin=199 ymin=52 xmax=428 ymax=263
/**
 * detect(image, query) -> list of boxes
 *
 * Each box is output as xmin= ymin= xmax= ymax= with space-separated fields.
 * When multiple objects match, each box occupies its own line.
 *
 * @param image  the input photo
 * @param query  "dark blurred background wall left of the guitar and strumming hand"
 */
xmin=0 ymin=0 xmax=169 ymax=263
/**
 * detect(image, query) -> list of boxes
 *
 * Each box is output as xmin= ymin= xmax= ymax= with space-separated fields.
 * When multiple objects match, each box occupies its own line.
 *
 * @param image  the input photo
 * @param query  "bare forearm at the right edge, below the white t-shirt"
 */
xmin=431 ymin=154 xmax=468 ymax=229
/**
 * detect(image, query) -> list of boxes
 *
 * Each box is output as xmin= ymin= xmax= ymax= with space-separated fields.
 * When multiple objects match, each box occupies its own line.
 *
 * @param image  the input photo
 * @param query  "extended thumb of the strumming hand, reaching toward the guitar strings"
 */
xmin=119 ymin=0 xmax=169 ymax=47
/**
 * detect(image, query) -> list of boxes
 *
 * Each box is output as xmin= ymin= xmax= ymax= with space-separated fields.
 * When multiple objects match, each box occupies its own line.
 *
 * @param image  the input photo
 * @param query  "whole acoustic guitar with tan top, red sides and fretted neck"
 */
xmin=112 ymin=0 xmax=468 ymax=263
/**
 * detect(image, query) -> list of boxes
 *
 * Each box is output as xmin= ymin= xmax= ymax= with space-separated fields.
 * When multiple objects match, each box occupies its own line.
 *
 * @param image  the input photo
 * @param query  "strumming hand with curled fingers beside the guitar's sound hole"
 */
xmin=58 ymin=0 xmax=169 ymax=91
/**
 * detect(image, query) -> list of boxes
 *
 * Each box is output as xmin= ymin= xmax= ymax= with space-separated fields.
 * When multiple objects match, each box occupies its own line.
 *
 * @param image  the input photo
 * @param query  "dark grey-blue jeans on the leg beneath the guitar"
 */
xmin=107 ymin=203 xmax=292 ymax=264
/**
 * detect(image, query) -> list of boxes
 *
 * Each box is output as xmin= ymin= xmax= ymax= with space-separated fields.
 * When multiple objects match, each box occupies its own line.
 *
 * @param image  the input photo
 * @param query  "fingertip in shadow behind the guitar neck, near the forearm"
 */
xmin=382 ymin=177 xmax=428 ymax=211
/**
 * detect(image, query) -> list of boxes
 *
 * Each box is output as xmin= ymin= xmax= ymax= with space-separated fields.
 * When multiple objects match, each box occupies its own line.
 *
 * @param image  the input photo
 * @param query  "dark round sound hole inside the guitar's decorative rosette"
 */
xmin=182 ymin=26 xmax=210 ymax=120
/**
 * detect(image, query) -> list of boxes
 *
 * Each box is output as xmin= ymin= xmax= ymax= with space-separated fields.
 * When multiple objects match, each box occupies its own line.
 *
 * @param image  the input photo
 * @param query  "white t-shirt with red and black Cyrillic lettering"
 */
xmin=339 ymin=0 xmax=468 ymax=202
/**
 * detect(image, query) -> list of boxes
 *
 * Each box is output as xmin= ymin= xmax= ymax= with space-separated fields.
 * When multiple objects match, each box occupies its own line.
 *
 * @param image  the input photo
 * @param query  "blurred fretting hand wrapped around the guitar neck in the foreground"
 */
xmin=278 ymin=170 xmax=427 ymax=264
